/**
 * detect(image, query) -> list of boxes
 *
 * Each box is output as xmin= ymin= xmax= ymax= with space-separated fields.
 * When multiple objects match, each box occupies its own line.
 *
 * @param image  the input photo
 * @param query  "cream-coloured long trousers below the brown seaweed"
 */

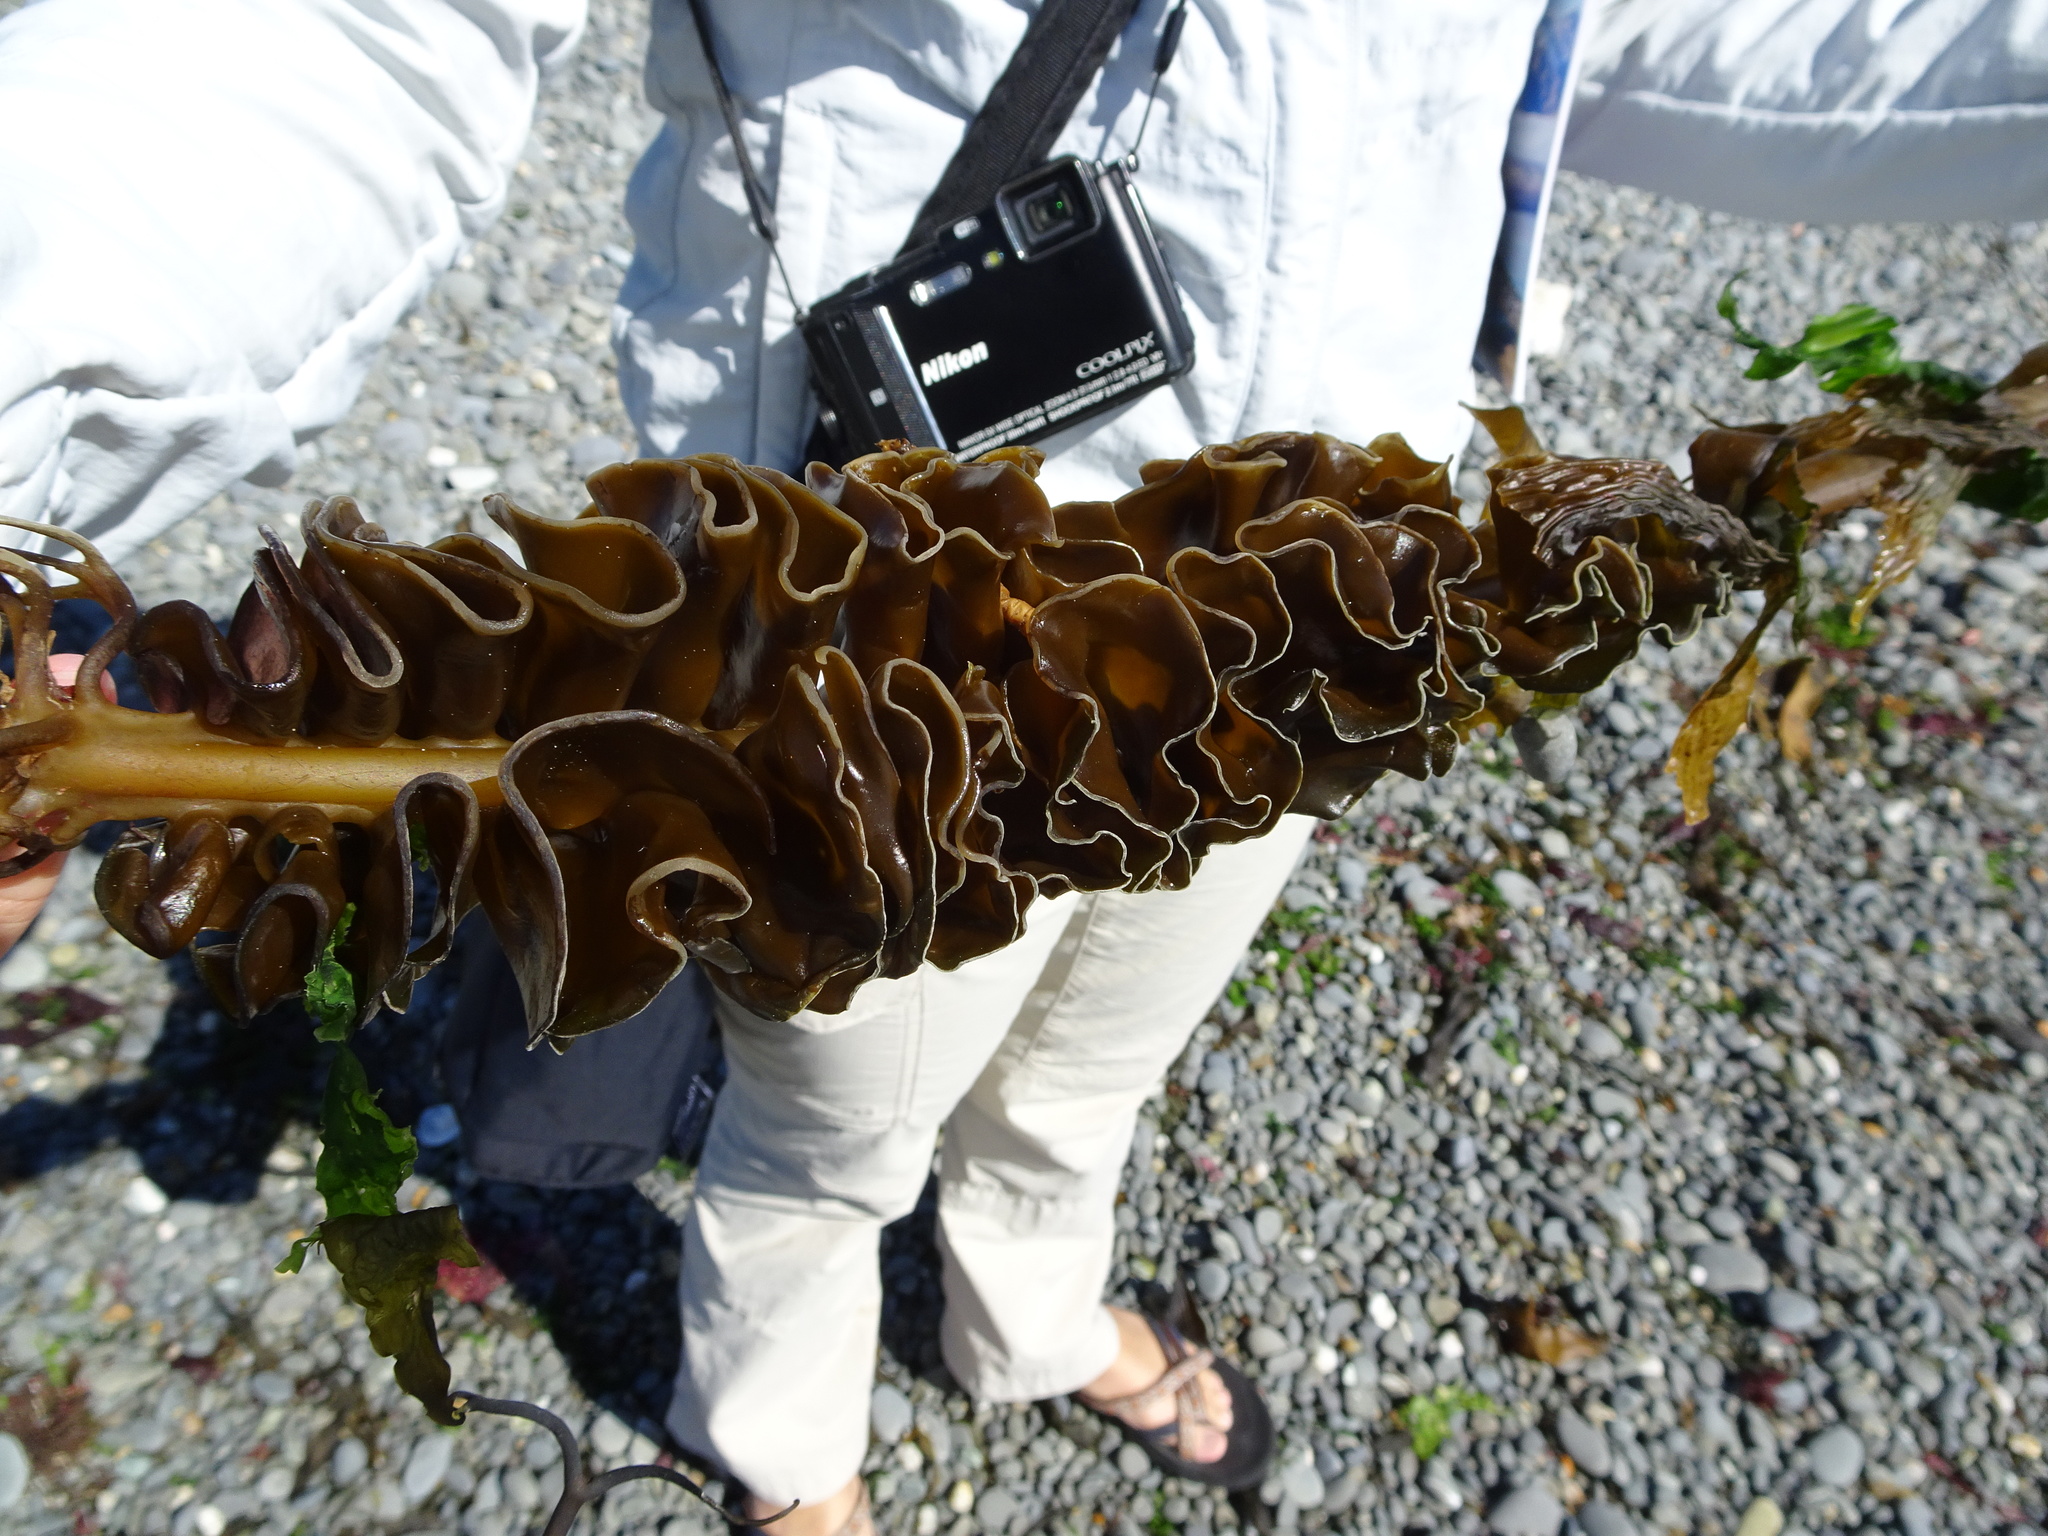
xmin=670 ymin=815 xmax=1315 ymax=1501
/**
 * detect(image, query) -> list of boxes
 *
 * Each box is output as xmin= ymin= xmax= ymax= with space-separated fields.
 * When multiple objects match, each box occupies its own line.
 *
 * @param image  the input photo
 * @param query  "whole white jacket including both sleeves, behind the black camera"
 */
xmin=0 ymin=0 xmax=2048 ymax=557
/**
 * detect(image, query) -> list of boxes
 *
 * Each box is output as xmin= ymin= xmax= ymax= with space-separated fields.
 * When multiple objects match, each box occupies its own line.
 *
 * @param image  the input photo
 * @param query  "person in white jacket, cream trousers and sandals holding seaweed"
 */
xmin=0 ymin=0 xmax=2048 ymax=1536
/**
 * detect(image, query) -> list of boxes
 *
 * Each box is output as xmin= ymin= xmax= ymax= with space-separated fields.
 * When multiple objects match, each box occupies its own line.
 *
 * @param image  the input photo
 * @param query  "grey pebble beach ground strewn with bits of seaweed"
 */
xmin=0 ymin=0 xmax=2048 ymax=1536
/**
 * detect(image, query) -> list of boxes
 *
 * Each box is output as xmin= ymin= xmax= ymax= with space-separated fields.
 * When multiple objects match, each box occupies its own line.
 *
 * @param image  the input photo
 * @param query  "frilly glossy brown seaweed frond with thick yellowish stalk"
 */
xmin=0 ymin=432 xmax=1769 ymax=1040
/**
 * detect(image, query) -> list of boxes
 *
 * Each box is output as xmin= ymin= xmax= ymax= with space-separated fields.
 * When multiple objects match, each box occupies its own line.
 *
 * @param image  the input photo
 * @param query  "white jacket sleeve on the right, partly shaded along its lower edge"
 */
xmin=1565 ymin=0 xmax=2048 ymax=223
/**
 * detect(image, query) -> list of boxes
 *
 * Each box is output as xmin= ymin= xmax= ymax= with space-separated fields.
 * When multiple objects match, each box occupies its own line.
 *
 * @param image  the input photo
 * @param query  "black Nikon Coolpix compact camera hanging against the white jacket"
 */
xmin=803 ymin=156 xmax=1194 ymax=466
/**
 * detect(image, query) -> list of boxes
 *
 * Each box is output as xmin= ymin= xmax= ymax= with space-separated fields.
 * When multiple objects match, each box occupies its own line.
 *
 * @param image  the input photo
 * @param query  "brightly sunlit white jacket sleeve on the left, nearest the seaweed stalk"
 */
xmin=0 ymin=0 xmax=584 ymax=557
